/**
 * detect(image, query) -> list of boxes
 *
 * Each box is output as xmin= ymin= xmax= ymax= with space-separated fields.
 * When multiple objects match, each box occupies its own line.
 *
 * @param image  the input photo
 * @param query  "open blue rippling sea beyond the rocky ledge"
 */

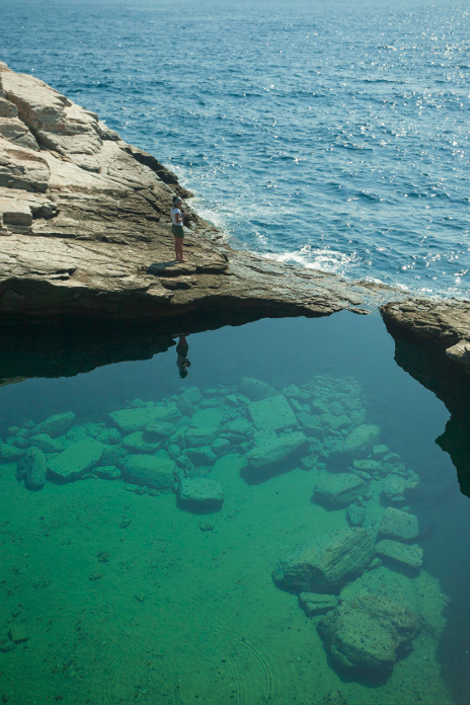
xmin=0 ymin=0 xmax=470 ymax=297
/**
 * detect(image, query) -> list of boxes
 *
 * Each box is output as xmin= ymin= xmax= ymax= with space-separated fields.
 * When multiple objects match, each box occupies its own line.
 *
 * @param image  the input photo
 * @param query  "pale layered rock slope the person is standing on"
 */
xmin=0 ymin=64 xmax=382 ymax=322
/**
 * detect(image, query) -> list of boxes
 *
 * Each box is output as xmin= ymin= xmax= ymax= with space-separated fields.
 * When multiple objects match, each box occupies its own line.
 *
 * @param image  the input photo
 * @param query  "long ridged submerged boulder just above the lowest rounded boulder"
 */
xmin=273 ymin=528 xmax=374 ymax=592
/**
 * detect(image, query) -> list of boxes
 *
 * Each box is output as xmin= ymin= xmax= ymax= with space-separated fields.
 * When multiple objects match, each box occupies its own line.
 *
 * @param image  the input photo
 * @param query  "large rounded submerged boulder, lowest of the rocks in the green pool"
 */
xmin=317 ymin=594 xmax=418 ymax=677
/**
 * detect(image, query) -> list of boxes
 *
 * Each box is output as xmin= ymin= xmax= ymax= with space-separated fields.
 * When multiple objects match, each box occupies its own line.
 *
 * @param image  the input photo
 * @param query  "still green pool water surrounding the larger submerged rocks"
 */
xmin=0 ymin=313 xmax=470 ymax=705
